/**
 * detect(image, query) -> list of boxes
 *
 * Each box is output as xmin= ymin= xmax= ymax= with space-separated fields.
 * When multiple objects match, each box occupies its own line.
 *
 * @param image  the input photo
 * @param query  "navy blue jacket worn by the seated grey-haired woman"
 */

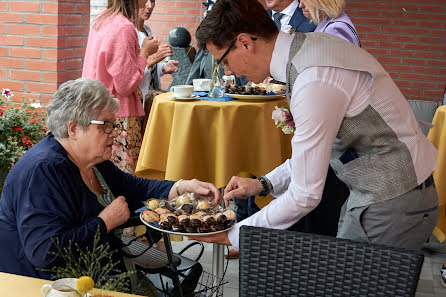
xmin=0 ymin=135 xmax=174 ymax=279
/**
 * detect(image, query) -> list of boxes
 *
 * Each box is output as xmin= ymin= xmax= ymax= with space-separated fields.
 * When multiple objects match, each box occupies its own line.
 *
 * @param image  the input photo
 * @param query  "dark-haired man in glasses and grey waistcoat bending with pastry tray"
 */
xmin=190 ymin=0 xmax=438 ymax=249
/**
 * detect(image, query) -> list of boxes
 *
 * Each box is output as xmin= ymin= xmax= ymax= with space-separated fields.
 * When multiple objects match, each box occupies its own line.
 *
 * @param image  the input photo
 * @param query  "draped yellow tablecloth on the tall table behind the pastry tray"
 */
xmin=136 ymin=93 xmax=291 ymax=187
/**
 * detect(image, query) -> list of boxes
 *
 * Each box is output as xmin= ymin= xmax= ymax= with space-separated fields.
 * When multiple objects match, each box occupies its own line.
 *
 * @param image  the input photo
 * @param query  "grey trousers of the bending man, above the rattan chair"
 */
xmin=337 ymin=185 xmax=438 ymax=249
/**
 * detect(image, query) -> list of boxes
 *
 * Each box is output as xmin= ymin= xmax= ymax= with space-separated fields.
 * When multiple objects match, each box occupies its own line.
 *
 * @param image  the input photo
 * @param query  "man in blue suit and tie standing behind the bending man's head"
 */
xmin=265 ymin=0 xmax=316 ymax=33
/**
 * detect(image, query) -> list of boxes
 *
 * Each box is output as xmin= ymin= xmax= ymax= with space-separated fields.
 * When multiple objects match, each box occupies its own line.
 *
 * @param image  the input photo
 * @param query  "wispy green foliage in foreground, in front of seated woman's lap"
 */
xmin=42 ymin=227 xmax=135 ymax=292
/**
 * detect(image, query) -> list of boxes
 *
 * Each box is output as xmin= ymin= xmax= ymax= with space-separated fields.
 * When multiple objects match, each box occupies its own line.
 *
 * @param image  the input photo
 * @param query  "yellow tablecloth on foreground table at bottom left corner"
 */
xmin=0 ymin=272 xmax=143 ymax=297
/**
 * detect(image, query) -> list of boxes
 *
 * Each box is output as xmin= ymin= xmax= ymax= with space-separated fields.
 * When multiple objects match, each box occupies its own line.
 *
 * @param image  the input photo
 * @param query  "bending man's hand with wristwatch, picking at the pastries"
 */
xmin=223 ymin=176 xmax=263 ymax=206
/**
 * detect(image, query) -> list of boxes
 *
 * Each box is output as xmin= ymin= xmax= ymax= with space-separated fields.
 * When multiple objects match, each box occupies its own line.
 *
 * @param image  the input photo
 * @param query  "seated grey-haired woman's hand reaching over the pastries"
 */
xmin=169 ymin=178 xmax=222 ymax=204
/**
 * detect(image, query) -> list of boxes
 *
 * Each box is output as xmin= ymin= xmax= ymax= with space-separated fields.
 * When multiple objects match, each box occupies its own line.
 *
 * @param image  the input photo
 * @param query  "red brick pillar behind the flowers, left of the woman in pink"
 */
xmin=0 ymin=0 xmax=90 ymax=105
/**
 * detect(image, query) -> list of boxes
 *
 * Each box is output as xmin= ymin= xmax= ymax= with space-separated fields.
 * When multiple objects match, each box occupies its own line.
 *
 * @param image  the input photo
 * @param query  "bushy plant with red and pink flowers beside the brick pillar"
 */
xmin=0 ymin=89 xmax=47 ymax=172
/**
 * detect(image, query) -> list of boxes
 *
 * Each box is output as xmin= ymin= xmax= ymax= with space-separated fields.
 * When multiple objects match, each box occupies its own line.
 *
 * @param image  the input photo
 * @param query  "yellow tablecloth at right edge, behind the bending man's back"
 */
xmin=427 ymin=105 xmax=446 ymax=242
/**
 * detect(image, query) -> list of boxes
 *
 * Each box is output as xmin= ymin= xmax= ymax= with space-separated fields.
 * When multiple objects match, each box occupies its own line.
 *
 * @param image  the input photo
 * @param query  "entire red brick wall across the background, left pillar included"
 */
xmin=0 ymin=0 xmax=446 ymax=104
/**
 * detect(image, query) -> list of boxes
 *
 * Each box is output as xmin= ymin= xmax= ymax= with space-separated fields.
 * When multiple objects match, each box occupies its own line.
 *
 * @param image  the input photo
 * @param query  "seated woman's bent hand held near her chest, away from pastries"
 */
xmin=98 ymin=196 xmax=130 ymax=232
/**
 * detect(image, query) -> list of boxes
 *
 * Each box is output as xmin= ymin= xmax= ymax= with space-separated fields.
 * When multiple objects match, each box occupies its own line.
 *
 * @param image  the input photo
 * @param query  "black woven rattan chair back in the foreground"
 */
xmin=239 ymin=226 xmax=424 ymax=297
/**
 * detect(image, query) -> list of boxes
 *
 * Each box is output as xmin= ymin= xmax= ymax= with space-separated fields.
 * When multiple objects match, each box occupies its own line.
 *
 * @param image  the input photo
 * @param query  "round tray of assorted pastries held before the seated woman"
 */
xmin=140 ymin=193 xmax=236 ymax=236
